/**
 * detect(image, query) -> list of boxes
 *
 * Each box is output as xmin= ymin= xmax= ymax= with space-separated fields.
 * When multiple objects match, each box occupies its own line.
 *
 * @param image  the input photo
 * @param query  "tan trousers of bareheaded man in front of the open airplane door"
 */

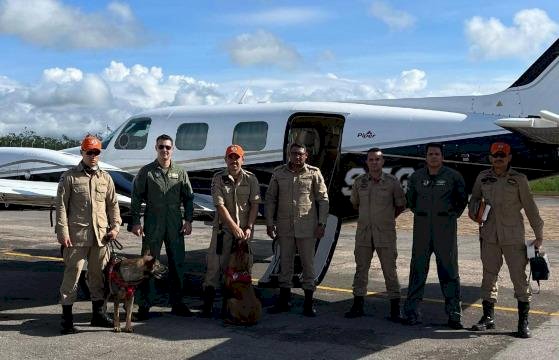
xmin=279 ymin=236 xmax=316 ymax=291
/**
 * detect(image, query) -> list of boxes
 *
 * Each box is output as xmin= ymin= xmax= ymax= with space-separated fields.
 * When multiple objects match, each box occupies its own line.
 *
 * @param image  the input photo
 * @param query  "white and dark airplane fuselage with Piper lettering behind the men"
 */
xmin=89 ymin=102 xmax=559 ymax=215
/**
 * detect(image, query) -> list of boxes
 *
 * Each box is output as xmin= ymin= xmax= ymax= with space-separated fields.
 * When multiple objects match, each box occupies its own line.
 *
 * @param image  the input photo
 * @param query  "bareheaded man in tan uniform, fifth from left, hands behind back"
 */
xmin=345 ymin=148 xmax=406 ymax=321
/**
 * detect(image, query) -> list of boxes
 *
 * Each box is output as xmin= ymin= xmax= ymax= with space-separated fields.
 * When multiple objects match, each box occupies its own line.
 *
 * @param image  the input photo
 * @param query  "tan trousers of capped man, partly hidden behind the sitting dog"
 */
xmin=203 ymin=228 xmax=252 ymax=289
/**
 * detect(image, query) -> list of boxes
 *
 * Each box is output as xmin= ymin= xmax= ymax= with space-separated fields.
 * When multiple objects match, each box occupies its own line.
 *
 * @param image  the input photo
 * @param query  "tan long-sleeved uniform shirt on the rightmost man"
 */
xmin=469 ymin=169 xmax=543 ymax=245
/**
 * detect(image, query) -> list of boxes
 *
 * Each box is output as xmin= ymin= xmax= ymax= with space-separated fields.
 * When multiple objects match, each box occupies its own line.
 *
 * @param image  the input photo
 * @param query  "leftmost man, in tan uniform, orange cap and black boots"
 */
xmin=55 ymin=136 xmax=121 ymax=334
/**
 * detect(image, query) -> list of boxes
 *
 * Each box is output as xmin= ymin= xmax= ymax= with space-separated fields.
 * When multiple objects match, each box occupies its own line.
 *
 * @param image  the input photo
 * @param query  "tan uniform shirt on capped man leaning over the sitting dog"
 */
xmin=212 ymin=169 xmax=260 ymax=228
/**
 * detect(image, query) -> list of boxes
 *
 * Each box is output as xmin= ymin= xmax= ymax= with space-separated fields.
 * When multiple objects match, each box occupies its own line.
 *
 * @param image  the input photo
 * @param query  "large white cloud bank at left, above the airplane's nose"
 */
xmin=0 ymin=61 xmax=227 ymax=138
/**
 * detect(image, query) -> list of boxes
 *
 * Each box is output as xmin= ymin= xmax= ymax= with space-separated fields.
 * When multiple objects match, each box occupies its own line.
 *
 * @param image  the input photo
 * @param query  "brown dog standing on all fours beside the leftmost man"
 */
xmin=105 ymin=255 xmax=164 ymax=332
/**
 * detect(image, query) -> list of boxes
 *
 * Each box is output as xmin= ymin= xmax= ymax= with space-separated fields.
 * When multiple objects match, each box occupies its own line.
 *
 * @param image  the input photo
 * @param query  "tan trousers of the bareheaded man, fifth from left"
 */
xmin=353 ymin=244 xmax=400 ymax=299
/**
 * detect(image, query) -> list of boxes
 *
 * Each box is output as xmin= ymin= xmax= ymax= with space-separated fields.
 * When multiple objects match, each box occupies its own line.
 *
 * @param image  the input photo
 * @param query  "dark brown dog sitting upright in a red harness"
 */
xmin=224 ymin=242 xmax=262 ymax=325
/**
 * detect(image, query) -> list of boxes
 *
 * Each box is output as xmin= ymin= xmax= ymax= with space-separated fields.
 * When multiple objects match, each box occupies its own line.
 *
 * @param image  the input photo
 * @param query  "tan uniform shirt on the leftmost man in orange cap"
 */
xmin=55 ymin=163 xmax=122 ymax=246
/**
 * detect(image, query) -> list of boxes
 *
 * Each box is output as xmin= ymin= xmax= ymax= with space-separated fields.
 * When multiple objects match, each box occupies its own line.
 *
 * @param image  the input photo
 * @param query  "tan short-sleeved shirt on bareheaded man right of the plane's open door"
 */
xmin=350 ymin=173 xmax=406 ymax=247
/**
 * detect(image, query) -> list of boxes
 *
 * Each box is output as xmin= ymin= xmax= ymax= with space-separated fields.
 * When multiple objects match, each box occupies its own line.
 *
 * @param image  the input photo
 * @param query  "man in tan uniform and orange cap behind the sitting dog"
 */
xmin=201 ymin=145 xmax=260 ymax=317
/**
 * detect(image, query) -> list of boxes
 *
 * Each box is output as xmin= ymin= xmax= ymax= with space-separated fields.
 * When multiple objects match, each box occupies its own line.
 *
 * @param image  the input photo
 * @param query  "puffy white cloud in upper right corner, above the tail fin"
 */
xmin=465 ymin=9 xmax=559 ymax=59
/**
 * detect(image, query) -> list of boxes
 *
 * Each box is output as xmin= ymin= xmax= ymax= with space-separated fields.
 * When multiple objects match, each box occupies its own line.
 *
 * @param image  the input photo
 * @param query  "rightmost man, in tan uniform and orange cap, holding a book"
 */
xmin=469 ymin=142 xmax=543 ymax=338
